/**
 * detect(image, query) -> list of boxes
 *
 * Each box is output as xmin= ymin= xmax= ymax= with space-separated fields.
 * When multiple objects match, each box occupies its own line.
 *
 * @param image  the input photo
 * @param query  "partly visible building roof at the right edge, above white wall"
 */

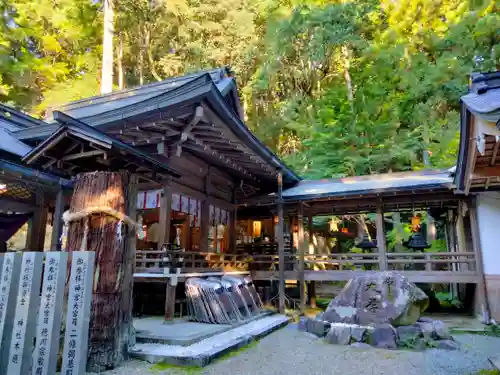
xmin=455 ymin=72 xmax=500 ymax=194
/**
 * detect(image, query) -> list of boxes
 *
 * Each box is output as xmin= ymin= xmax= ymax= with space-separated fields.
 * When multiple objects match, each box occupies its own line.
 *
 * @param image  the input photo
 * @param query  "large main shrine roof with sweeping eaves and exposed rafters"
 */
xmin=14 ymin=68 xmax=300 ymax=196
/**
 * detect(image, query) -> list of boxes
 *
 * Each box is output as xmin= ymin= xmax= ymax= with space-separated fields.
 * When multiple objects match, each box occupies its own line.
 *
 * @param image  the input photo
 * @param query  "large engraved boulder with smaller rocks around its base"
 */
xmin=299 ymin=272 xmax=458 ymax=350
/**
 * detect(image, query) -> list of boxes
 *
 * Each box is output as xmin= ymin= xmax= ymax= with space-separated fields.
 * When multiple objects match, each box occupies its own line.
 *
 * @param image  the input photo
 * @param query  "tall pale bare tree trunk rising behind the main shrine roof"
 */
xmin=101 ymin=0 xmax=115 ymax=94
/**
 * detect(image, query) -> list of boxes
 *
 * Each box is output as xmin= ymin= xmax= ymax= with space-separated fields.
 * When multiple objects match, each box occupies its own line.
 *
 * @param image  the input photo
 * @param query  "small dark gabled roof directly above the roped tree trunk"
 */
xmin=23 ymin=112 xmax=180 ymax=181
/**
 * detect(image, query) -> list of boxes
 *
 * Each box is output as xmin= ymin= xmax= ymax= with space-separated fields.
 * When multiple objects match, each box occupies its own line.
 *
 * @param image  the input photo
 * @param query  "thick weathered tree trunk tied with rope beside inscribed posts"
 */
xmin=67 ymin=172 xmax=137 ymax=373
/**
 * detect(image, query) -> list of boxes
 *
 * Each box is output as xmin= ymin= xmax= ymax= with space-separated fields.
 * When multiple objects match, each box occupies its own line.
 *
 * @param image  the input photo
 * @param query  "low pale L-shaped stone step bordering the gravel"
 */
xmin=129 ymin=315 xmax=289 ymax=367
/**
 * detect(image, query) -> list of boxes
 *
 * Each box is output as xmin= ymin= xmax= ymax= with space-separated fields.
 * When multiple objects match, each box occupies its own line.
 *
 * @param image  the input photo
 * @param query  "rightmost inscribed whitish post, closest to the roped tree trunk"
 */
xmin=61 ymin=251 xmax=95 ymax=375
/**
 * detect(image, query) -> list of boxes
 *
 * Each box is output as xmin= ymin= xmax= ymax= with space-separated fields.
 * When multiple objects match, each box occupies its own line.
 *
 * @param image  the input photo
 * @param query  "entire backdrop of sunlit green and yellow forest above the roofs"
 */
xmin=0 ymin=0 xmax=500 ymax=178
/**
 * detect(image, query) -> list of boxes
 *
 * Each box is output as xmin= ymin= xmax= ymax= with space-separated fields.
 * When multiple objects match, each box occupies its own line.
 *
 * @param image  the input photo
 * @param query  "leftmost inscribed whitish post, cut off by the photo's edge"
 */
xmin=0 ymin=253 xmax=21 ymax=375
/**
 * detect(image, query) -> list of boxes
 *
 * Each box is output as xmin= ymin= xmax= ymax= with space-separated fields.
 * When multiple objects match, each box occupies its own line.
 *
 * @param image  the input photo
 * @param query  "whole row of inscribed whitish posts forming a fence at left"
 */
xmin=0 ymin=251 xmax=95 ymax=375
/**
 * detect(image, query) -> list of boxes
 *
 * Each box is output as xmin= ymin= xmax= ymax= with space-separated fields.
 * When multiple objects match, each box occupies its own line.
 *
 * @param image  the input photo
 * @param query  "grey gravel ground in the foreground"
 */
xmin=90 ymin=325 xmax=500 ymax=375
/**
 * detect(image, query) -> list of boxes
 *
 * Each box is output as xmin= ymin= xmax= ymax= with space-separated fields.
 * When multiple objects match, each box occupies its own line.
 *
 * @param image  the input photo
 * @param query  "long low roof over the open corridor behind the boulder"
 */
xmin=237 ymin=170 xmax=458 ymax=217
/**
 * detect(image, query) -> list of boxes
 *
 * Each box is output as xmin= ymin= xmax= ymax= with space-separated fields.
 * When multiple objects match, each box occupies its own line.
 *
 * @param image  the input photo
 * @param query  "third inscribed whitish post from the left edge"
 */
xmin=31 ymin=252 xmax=68 ymax=375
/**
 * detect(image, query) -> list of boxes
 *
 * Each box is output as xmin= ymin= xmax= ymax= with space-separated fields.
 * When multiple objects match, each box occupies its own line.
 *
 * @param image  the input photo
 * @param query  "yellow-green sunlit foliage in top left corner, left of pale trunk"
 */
xmin=0 ymin=0 xmax=101 ymax=112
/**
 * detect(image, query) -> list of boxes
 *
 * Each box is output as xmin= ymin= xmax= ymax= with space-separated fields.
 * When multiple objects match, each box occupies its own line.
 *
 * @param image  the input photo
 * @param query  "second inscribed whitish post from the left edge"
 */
xmin=7 ymin=252 xmax=44 ymax=375
